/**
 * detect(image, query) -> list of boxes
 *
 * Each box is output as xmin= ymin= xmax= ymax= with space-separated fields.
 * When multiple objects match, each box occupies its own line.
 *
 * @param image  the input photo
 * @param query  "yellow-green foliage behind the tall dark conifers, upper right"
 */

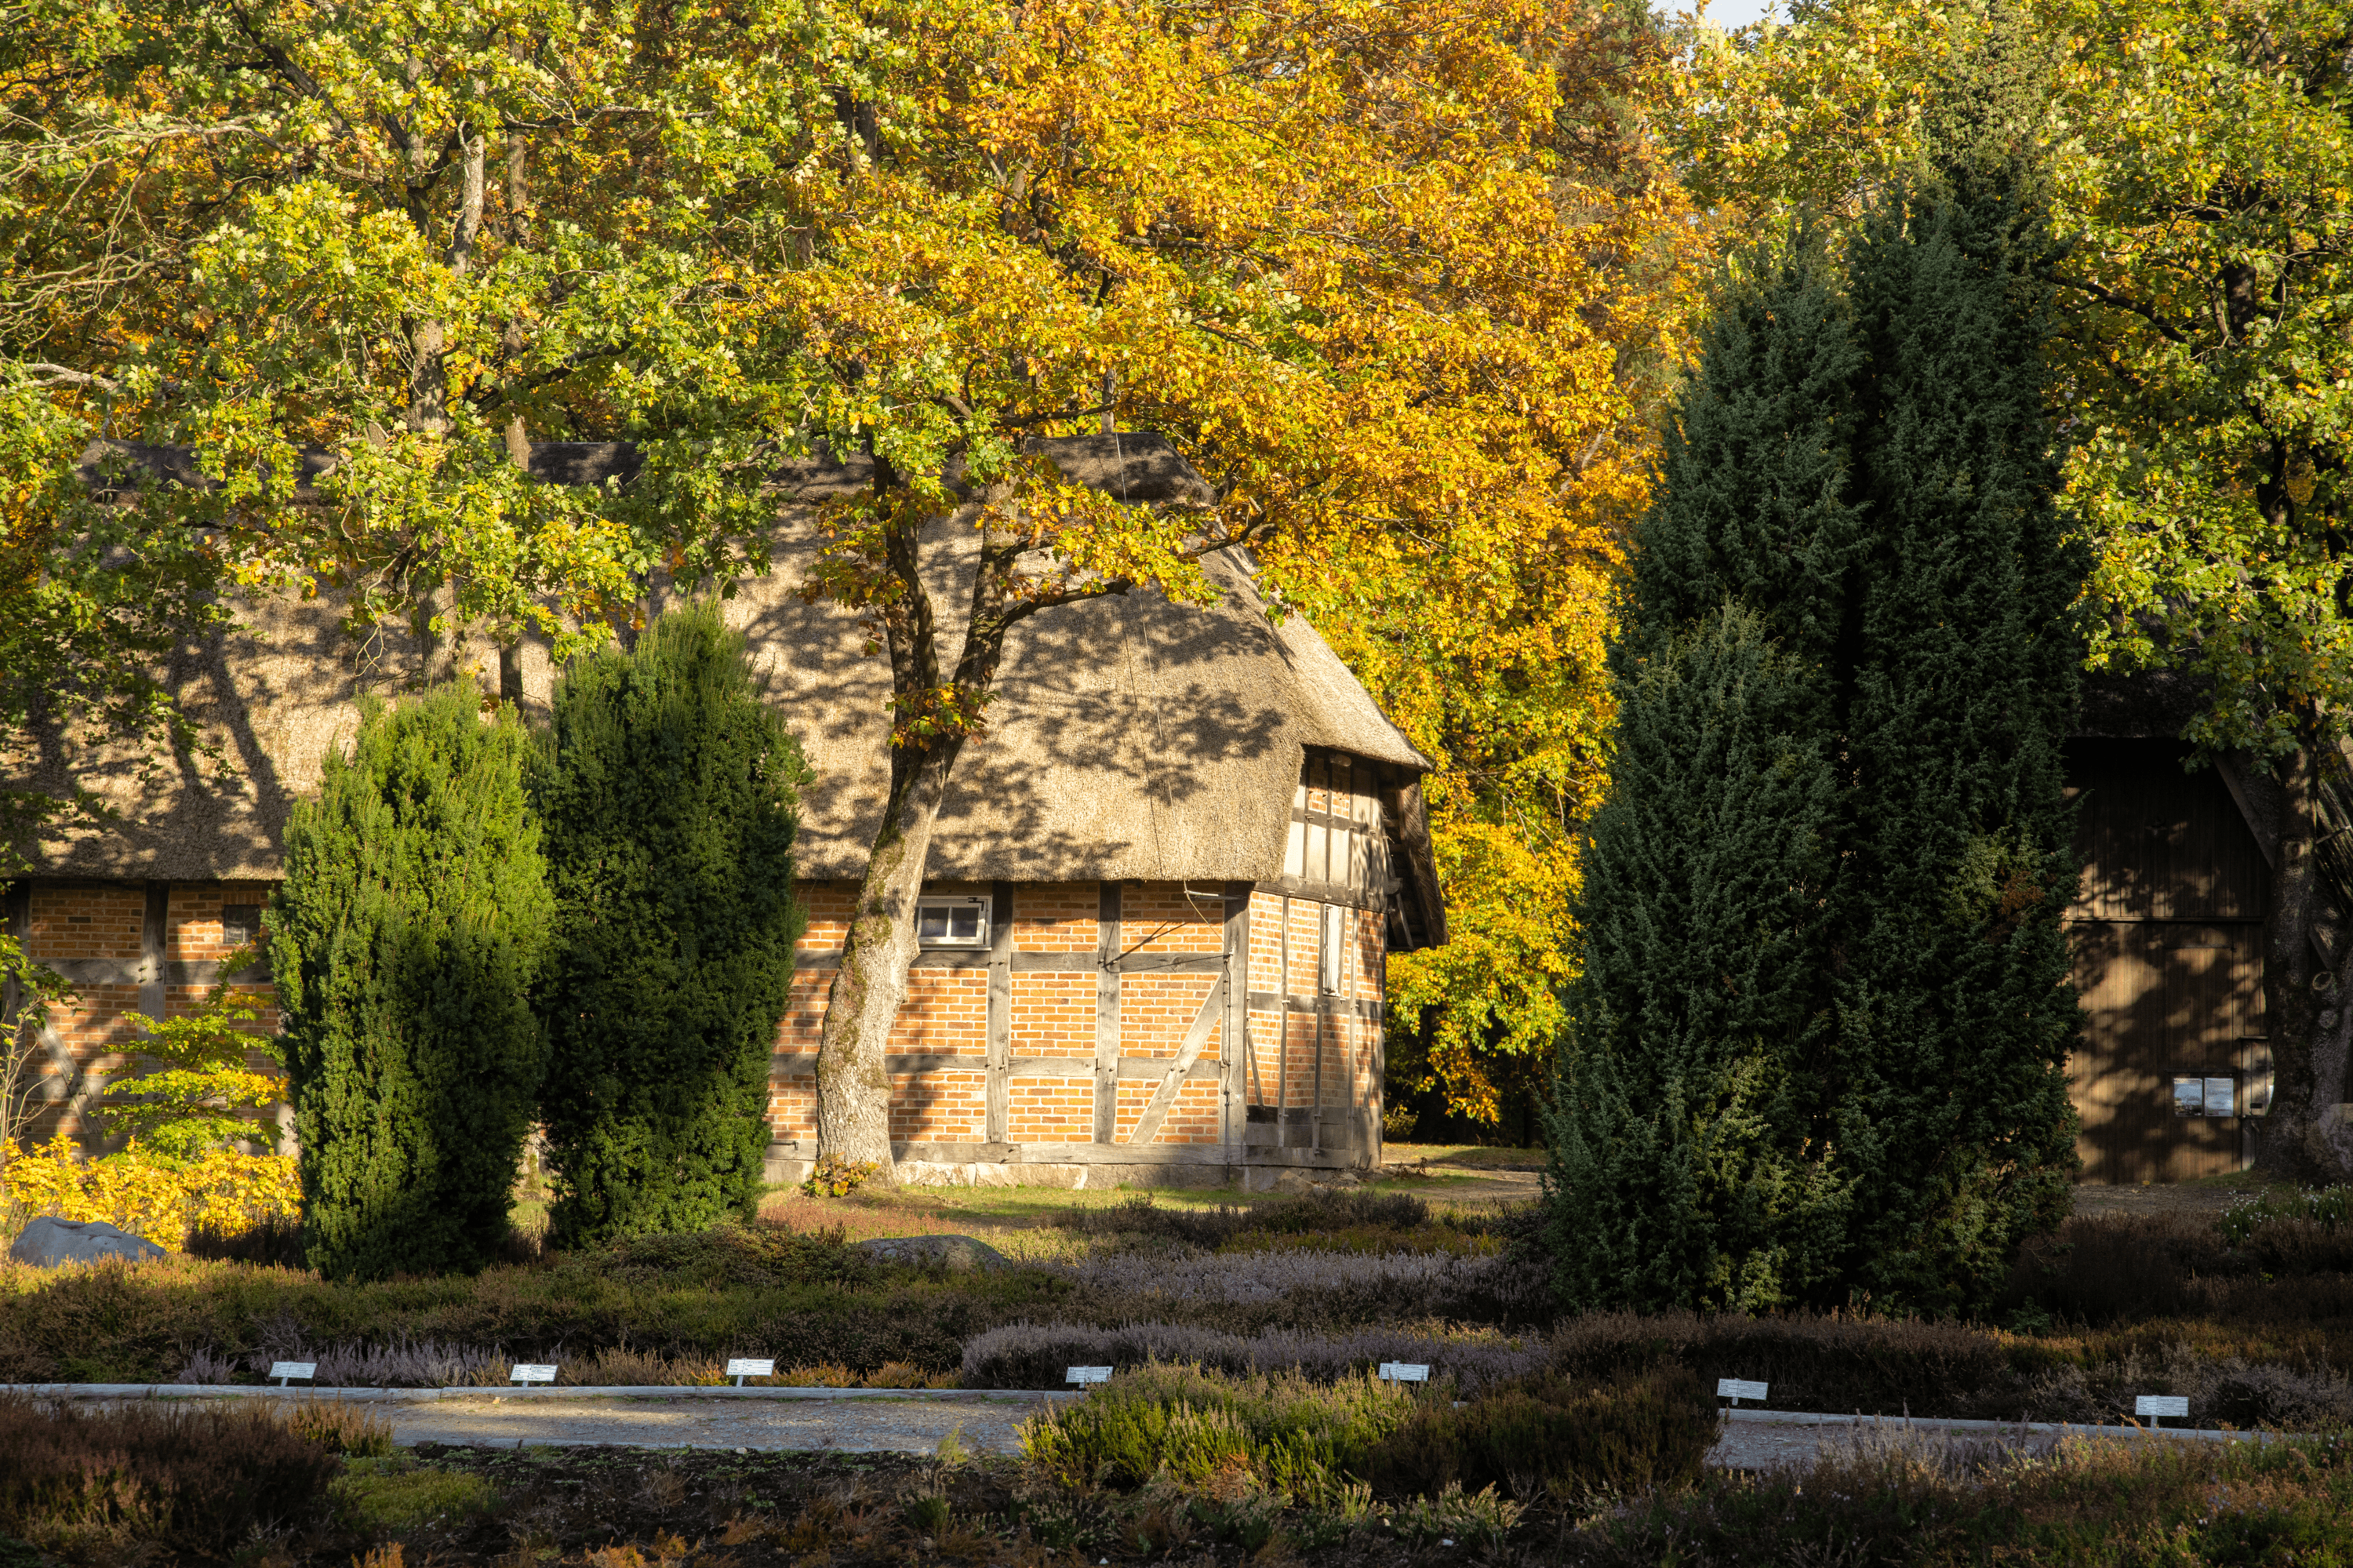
xmin=1682 ymin=0 xmax=2353 ymax=755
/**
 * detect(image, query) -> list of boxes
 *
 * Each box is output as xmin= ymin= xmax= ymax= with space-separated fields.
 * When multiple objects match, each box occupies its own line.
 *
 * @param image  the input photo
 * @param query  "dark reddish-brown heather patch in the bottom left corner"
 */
xmin=0 ymin=1394 xmax=341 ymax=1561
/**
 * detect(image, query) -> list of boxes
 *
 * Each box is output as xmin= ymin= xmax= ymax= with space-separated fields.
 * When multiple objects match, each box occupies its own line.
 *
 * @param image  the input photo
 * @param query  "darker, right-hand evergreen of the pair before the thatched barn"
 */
xmin=532 ymin=605 xmax=807 ymax=1246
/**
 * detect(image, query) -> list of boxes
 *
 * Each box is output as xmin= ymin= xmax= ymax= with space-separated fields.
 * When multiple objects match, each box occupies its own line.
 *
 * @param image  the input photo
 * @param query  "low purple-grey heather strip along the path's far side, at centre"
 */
xmin=960 ymin=1323 xmax=1546 ymax=1392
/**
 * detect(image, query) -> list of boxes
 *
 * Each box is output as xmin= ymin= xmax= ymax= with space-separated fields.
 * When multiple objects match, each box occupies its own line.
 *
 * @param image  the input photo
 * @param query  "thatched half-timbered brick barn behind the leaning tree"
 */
xmin=7 ymin=438 xmax=1445 ymax=1187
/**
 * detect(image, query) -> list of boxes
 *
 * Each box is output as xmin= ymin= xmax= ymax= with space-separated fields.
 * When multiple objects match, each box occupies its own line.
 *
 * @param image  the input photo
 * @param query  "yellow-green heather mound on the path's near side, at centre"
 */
xmin=1021 ymin=1363 xmax=1414 ymax=1507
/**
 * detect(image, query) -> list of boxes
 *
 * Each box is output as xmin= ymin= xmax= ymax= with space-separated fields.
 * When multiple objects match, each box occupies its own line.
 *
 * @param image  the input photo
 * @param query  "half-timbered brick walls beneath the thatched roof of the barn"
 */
xmin=9 ymin=753 xmax=1391 ymax=1166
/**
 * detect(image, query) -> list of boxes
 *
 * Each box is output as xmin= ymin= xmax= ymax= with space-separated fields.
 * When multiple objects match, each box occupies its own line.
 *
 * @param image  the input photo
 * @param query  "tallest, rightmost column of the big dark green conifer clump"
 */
xmin=1831 ymin=165 xmax=2087 ymax=1309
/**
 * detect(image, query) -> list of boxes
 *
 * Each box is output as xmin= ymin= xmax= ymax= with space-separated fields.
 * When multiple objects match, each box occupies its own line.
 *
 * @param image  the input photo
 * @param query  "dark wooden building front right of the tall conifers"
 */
xmin=2066 ymin=739 xmax=2271 ymax=1184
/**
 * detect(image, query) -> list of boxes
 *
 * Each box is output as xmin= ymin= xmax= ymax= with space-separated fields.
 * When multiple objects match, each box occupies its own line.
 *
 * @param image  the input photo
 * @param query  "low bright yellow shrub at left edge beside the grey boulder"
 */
xmin=0 ymin=1133 xmax=301 ymax=1250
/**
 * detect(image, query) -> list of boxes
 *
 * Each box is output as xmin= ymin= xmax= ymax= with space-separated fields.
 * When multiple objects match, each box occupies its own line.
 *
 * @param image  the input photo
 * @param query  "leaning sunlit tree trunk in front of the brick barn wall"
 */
xmin=816 ymin=741 xmax=958 ymax=1182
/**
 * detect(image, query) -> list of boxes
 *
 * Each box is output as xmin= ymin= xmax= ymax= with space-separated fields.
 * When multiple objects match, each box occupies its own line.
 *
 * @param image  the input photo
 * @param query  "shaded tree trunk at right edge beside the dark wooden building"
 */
xmin=2254 ymin=744 xmax=2353 ymax=1182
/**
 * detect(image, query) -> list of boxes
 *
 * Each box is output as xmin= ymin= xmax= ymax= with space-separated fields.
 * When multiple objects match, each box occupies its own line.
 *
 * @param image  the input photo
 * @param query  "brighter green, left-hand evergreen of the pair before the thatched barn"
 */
xmin=271 ymin=687 xmax=553 ymax=1279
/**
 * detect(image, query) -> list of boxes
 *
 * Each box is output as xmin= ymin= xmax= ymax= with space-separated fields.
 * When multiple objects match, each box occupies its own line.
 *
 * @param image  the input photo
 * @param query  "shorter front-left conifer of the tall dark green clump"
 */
xmin=1553 ymin=602 xmax=1845 ymax=1309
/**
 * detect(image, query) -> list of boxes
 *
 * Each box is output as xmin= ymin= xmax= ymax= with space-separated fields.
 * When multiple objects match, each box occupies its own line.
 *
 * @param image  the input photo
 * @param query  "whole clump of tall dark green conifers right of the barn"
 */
xmin=1551 ymin=162 xmax=2085 ymax=1312
